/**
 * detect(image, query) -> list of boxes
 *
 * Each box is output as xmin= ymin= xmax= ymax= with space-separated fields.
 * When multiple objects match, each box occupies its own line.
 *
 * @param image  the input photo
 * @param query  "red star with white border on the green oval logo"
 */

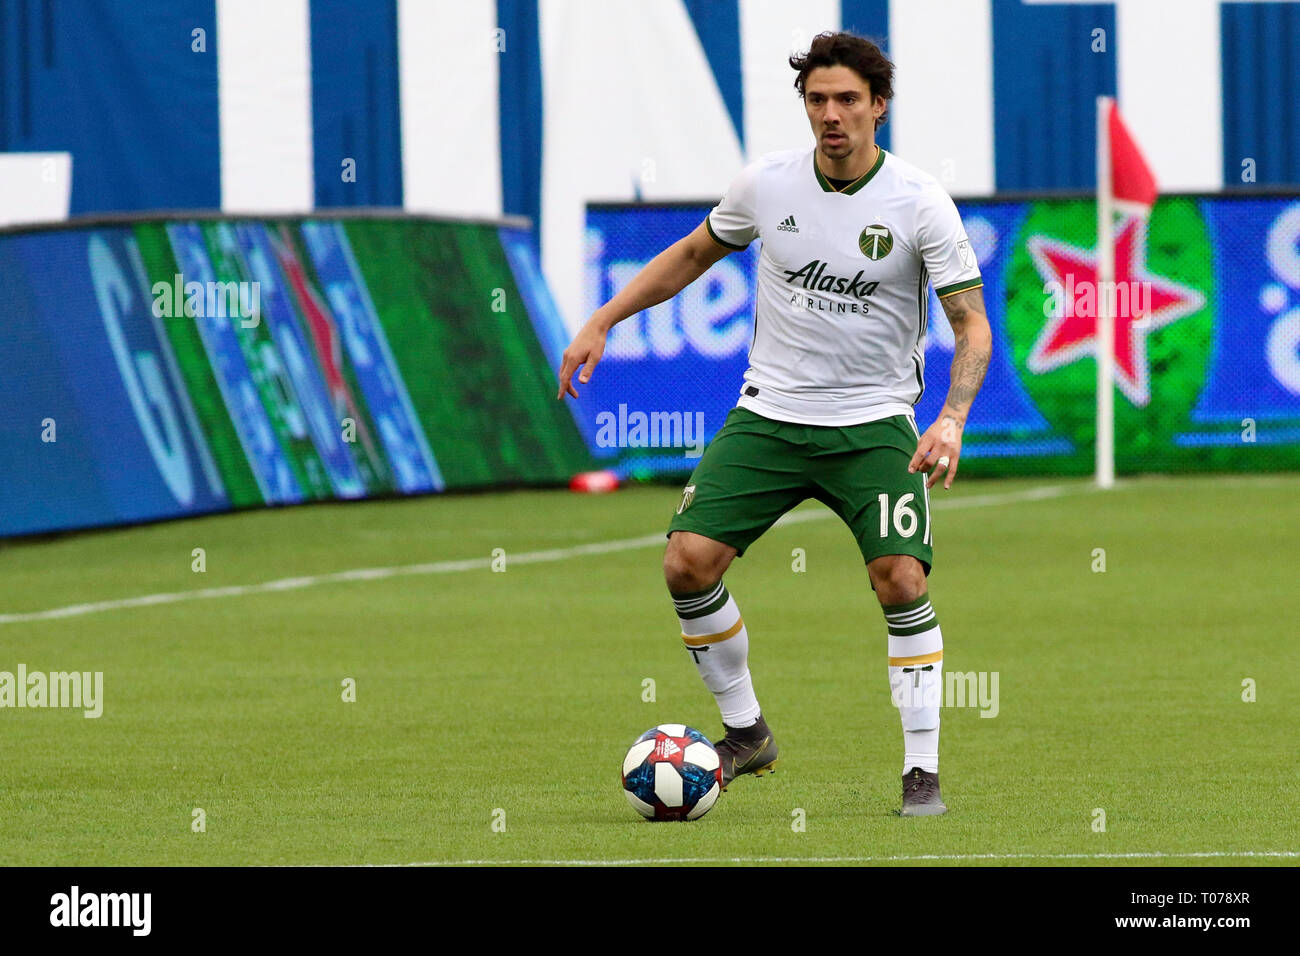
xmin=1026 ymin=216 xmax=1205 ymax=407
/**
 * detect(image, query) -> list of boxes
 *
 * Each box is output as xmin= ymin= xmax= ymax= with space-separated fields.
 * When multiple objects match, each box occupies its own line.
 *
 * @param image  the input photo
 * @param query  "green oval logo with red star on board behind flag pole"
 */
xmin=1005 ymin=199 xmax=1214 ymax=470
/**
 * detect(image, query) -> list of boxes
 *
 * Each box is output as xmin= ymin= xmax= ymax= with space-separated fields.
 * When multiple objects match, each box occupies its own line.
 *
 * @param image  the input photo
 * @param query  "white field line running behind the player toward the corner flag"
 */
xmin=0 ymin=484 xmax=1095 ymax=624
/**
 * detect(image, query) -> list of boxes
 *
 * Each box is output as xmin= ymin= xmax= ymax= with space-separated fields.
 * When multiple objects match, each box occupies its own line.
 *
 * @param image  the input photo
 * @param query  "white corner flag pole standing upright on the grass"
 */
xmin=1093 ymin=96 xmax=1115 ymax=488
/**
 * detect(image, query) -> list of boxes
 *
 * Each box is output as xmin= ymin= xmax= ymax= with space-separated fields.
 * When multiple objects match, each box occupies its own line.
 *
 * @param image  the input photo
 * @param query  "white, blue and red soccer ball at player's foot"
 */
xmin=623 ymin=723 xmax=723 ymax=819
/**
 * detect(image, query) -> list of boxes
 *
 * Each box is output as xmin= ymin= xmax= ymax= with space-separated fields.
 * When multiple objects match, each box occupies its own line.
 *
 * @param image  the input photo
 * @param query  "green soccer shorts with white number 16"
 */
xmin=668 ymin=406 xmax=933 ymax=575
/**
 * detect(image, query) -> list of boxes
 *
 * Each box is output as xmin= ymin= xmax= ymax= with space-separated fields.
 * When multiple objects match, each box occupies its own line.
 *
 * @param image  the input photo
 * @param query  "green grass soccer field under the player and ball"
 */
xmin=0 ymin=475 xmax=1300 ymax=865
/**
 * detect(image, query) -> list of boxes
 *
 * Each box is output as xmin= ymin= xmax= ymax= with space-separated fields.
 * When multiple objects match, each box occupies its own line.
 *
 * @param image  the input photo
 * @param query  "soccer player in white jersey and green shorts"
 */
xmin=559 ymin=33 xmax=992 ymax=816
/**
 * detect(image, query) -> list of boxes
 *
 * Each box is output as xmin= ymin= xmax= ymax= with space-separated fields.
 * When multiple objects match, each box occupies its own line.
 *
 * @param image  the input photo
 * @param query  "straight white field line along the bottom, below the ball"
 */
xmin=354 ymin=849 xmax=1300 ymax=866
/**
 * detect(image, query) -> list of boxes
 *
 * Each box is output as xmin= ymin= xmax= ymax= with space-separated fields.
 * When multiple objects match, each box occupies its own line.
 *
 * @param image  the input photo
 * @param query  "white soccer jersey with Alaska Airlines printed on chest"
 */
xmin=705 ymin=150 xmax=983 ymax=425
